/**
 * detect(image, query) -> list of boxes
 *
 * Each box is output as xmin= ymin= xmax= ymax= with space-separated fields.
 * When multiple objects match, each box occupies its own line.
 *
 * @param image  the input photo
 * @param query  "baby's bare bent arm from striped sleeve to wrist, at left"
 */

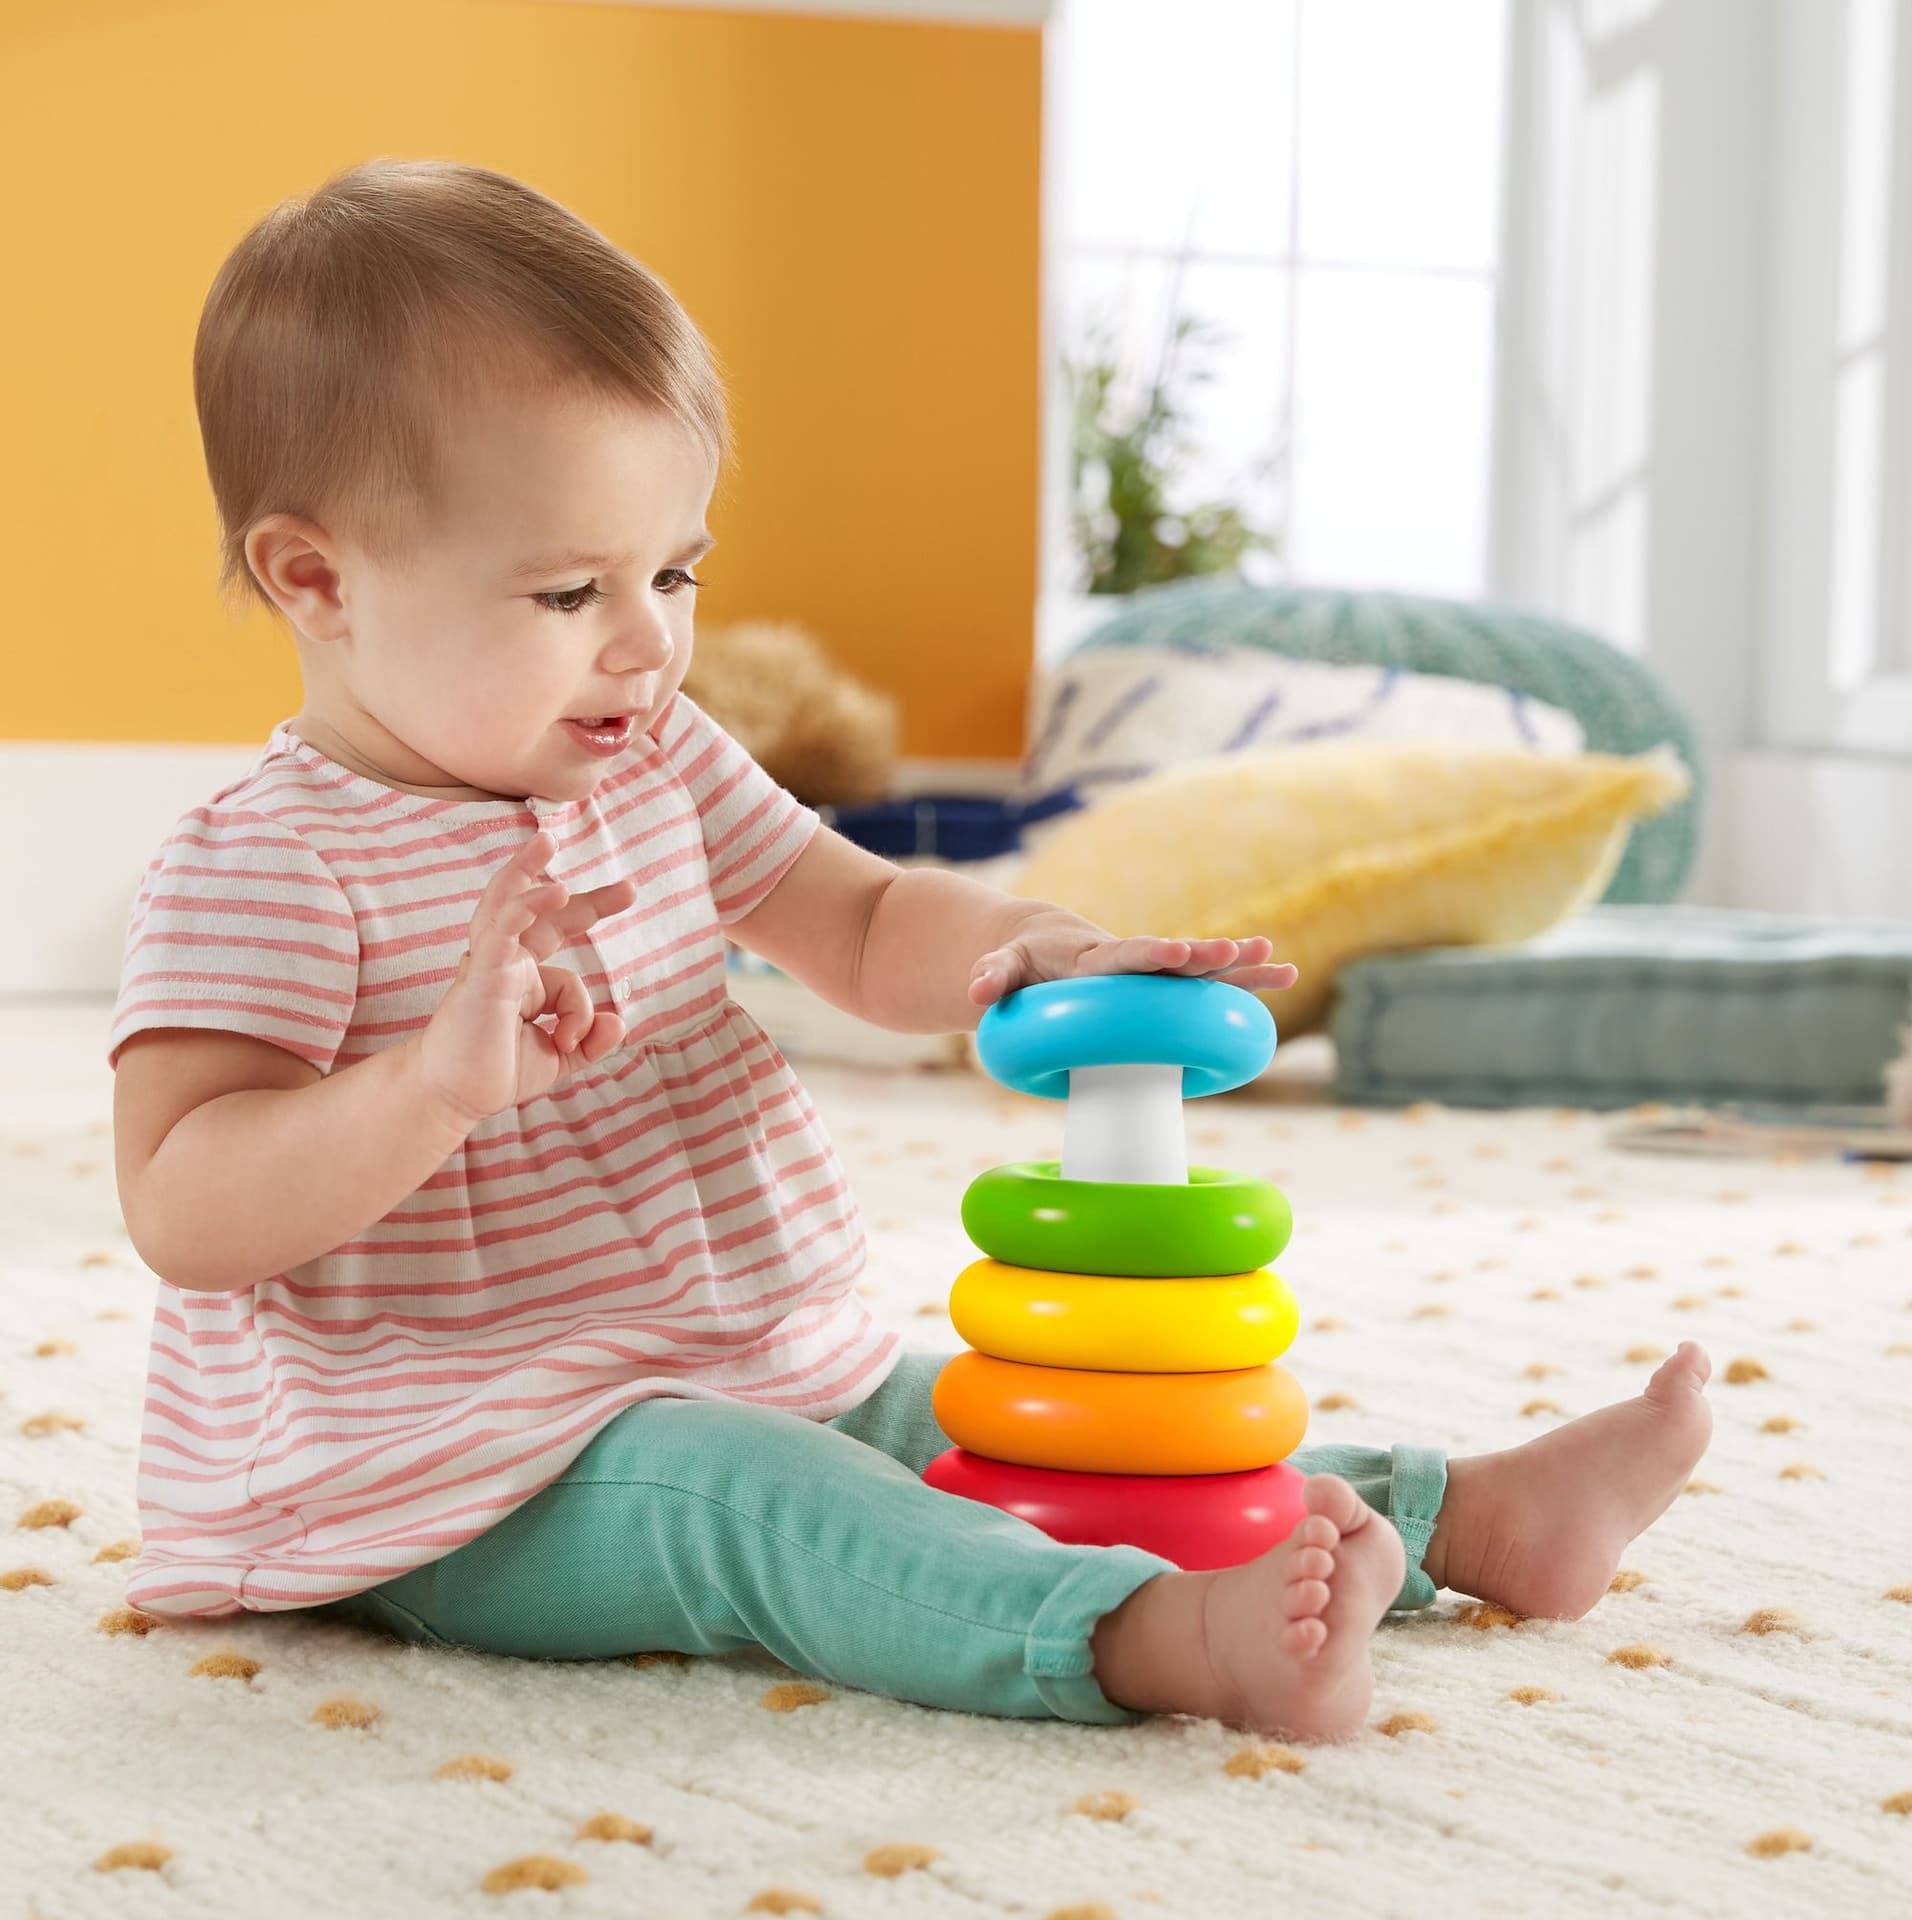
xmin=113 ymin=1027 xmax=476 ymax=1292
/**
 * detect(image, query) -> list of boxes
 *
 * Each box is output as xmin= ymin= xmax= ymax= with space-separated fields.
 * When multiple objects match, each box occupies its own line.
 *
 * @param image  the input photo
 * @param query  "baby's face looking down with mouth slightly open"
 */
xmin=307 ymin=399 xmax=716 ymax=801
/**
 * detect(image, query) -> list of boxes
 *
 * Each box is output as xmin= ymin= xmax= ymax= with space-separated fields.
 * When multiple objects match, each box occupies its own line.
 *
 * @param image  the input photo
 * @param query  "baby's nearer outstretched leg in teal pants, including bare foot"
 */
xmin=328 ymin=1367 xmax=1399 ymax=1736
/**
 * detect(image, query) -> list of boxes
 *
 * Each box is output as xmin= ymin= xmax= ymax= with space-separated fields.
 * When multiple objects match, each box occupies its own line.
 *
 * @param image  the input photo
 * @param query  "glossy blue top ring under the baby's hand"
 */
xmin=975 ymin=973 xmax=1275 ymax=1100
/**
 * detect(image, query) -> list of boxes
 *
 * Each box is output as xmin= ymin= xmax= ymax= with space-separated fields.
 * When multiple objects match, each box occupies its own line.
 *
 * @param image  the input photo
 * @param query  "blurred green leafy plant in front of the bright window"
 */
xmin=1062 ymin=301 xmax=1280 ymax=593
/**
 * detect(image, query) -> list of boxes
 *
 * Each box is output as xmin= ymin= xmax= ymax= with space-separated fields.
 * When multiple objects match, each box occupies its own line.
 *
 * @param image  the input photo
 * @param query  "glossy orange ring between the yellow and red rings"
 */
xmin=929 ymin=1352 xmax=1307 ymax=1475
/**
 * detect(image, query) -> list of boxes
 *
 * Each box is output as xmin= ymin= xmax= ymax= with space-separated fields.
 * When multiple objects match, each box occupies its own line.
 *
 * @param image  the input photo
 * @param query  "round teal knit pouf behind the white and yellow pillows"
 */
xmin=1071 ymin=576 xmax=1703 ymax=904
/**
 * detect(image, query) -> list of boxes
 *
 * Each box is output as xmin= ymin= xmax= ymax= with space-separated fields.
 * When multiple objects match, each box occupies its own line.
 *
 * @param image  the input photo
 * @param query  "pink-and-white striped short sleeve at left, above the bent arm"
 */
xmin=108 ymin=803 xmax=359 ymax=1073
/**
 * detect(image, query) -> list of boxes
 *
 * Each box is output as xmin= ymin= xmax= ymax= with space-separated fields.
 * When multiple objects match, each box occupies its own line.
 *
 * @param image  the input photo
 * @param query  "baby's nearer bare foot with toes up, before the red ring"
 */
xmin=1092 ymin=1475 xmax=1405 ymax=1740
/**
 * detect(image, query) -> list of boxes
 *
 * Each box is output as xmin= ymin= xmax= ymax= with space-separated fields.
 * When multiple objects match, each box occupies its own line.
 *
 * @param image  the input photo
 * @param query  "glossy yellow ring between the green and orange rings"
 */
xmin=950 ymin=1260 xmax=1300 ymax=1373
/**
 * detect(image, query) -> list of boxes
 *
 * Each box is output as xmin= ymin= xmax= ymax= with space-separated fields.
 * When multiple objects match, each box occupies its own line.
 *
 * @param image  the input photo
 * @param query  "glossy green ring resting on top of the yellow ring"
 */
xmin=962 ymin=1160 xmax=1294 ymax=1281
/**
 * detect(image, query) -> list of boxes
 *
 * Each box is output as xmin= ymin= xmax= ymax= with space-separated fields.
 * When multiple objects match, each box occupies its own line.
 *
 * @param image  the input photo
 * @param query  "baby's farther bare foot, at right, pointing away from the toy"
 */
xmin=1422 ymin=1340 xmax=1712 ymax=1620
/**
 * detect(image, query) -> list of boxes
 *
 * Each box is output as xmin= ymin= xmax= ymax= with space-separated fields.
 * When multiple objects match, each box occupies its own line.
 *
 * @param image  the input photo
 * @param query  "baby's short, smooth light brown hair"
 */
xmin=192 ymin=159 xmax=729 ymax=614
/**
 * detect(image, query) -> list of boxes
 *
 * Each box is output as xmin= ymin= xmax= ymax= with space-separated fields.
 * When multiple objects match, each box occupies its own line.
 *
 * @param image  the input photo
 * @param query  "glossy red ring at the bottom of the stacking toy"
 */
xmin=923 ymin=1448 xmax=1307 ymax=1571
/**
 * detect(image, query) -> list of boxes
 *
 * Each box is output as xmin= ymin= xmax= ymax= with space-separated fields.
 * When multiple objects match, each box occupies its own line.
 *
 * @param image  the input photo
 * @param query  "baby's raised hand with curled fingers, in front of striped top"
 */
xmin=417 ymin=828 xmax=637 ymax=1127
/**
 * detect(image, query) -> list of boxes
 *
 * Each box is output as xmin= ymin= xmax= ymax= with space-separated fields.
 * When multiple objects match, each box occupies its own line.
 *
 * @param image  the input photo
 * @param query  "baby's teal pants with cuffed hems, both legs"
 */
xmin=313 ymin=1354 xmax=1447 ymax=1724
